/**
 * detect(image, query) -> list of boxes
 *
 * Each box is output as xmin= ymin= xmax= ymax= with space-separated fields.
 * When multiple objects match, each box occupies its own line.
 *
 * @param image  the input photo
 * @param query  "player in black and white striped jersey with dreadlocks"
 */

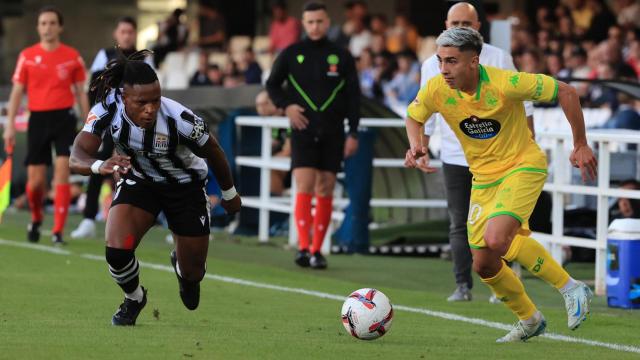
xmin=70 ymin=50 xmax=241 ymax=325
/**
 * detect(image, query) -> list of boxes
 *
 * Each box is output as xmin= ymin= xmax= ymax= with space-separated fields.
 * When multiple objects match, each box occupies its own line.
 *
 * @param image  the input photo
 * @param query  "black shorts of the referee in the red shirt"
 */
xmin=25 ymin=108 xmax=77 ymax=165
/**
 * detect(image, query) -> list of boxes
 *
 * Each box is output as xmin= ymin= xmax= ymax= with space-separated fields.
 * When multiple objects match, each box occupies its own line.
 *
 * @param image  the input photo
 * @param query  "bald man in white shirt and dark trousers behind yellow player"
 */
xmin=418 ymin=2 xmax=534 ymax=301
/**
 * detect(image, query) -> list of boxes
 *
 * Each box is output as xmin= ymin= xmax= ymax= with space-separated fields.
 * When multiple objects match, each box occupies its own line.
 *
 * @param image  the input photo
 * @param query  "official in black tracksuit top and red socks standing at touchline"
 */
xmin=267 ymin=2 xmax=360 ymax=269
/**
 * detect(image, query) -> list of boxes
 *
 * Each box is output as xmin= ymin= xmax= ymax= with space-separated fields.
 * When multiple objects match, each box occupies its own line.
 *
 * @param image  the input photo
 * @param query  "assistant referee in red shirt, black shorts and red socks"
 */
xmin=3 ymin=6 xmax=89 ymax=244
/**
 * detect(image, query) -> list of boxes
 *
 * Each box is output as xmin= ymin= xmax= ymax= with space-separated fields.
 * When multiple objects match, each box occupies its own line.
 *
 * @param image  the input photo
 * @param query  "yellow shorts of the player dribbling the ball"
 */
xmin=467 ymin=167 xmax=547 ymax=249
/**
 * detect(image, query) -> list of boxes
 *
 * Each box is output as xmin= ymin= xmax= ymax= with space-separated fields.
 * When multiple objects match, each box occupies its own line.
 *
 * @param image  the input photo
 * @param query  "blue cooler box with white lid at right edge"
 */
xmin=606 ymin=219 xmax=640 ymax=309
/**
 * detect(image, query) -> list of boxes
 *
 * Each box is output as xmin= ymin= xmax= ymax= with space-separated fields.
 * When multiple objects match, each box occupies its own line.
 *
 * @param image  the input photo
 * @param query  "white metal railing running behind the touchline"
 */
xmin=236 ymin=116 xmax=640 ymax=295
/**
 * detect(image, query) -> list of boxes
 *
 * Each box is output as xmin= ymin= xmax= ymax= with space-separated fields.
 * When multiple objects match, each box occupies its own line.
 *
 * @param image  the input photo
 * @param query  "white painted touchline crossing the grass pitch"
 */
xmin=0 ymin=239 xmax=640 ymax=354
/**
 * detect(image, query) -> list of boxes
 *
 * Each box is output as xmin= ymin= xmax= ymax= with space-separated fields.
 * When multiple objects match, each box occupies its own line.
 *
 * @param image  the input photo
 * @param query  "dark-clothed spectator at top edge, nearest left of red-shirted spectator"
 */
xmin=198 ymin=0 xmax=227 ymax=52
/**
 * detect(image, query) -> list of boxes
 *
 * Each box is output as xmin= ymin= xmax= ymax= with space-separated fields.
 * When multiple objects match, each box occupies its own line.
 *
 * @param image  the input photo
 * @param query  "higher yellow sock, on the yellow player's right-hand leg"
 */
xmin=503 ymin=235 xmax=569 ymax=289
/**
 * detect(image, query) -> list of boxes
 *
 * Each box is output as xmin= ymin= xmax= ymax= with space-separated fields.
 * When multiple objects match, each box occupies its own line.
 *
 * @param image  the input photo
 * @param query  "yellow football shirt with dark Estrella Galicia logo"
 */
xmin=407 ymin=65 xmax=558 ymax=177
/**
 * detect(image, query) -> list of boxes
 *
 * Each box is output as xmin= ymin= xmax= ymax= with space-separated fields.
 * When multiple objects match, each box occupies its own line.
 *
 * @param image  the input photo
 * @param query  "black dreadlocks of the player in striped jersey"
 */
xmin=91 ymin=49 xmax=158 ymax=107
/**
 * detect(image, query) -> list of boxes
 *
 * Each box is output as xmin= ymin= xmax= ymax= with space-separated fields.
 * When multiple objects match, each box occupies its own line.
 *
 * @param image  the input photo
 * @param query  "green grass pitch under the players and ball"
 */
xmin=0 ymin=213 xmax=640 ymax=360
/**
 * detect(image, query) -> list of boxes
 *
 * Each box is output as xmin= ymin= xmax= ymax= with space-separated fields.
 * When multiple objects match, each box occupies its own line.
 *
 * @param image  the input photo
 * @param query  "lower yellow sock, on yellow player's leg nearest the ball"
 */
xmin=481 ymin=263 xmax=537 ymax=320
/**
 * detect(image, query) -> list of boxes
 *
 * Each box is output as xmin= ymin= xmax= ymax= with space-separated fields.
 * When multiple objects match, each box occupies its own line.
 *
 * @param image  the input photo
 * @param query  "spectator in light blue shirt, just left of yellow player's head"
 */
xmin=384 ymin=50 xmax=420 ymax=110
